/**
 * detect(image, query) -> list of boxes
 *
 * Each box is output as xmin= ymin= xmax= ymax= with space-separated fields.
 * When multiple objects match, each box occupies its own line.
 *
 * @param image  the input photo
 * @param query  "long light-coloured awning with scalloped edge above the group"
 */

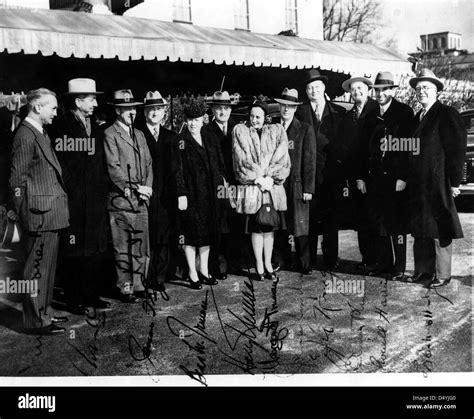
xmin=0 ymin=9 xmax=411 ymax=77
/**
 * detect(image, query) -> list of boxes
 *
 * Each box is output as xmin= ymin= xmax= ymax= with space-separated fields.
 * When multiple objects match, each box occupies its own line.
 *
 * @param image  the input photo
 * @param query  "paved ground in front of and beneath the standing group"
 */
xmin=0 ymin=214 xmax=474 ymax=380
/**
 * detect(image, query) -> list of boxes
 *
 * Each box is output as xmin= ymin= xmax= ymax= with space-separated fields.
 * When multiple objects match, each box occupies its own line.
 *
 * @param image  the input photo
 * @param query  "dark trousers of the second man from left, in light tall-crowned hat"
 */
xmin=59 ymin=253 xmax=102 ymax=306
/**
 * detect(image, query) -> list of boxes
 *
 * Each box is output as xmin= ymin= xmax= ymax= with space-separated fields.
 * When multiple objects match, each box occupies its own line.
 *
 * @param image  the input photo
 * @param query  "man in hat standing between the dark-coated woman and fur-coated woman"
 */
xmin=205 ymin=91 xmax=244 ymax=281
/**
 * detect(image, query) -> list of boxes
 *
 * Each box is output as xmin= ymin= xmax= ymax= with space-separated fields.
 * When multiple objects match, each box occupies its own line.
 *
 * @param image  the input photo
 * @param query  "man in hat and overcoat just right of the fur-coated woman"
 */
xmin=275 ymin=88 xmax=316 ymax=275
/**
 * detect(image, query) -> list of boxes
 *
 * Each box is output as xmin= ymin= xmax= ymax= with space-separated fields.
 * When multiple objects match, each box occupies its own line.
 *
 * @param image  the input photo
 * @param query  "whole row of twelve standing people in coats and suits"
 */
xmin=8 ymin=69 xmax=466 ymax=334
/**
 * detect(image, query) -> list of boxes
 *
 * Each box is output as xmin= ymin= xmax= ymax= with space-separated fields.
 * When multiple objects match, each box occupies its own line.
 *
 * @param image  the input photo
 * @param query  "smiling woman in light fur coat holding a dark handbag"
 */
xmin=232 ymin=101 xmax=291 ymax=281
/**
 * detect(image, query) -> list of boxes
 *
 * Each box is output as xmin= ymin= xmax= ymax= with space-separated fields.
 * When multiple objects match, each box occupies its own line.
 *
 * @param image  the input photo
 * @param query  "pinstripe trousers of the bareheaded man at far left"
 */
xmin=21 ymin=231 xmax=59 ymax=328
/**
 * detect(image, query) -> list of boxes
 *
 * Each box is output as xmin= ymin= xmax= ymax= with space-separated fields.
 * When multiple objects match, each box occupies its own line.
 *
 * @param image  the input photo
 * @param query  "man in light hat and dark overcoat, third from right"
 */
xmin=339 ymin=77 xmax=379 ymax=273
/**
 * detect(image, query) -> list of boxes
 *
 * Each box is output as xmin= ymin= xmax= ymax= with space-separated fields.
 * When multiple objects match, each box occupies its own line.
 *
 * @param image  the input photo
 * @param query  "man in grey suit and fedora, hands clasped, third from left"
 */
xmin=105 ymin=89 xmax=153 ymax=303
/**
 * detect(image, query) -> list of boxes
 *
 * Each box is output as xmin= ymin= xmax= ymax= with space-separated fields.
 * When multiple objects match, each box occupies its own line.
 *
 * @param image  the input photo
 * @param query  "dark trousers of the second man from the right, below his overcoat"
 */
xmin=377 ymin=234 xmax=407 ymax=273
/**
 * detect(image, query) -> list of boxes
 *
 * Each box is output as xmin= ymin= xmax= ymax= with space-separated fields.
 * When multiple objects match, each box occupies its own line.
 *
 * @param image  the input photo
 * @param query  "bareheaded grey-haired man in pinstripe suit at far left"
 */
xmin=10 ymin=88 xmax=69 ymax=334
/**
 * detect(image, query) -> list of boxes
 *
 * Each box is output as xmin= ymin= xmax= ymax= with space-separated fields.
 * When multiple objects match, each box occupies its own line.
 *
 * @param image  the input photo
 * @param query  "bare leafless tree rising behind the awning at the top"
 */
xmin=323 ymin=0 xmax=380 ymax=42
